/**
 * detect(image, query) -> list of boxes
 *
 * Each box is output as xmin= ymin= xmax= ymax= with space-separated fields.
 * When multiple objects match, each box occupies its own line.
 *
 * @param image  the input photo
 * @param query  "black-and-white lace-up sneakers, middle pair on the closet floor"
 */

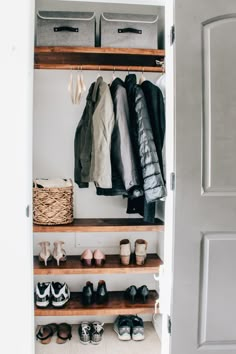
xmin=78 ymin=321 xmax=104 ymax=344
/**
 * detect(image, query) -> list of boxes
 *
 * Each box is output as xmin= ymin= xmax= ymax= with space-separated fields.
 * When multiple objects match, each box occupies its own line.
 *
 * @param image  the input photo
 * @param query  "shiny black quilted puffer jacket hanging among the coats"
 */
xmin=125 ymin=74 xmax=166 ymax=203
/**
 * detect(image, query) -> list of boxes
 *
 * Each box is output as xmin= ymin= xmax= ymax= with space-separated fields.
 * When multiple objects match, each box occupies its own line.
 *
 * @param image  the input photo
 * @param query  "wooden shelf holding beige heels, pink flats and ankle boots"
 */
xmin=34 ymin=254 xmax=162 ymax=275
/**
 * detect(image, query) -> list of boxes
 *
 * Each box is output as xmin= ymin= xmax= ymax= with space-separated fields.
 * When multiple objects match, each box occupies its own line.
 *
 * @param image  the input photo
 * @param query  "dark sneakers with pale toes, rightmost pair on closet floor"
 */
xmin=113 ymin=315 xmax=144 ymax=341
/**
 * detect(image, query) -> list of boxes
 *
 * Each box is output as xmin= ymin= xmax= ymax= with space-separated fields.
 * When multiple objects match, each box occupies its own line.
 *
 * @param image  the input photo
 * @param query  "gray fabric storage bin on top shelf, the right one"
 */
xmin=101 ymin=12 xmax=158 ymax=49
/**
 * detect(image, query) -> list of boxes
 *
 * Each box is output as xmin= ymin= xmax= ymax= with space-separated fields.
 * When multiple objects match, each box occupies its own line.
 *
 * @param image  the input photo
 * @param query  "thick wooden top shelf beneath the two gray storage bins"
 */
xmin=34 ymin=47 xmax=165 ymax=72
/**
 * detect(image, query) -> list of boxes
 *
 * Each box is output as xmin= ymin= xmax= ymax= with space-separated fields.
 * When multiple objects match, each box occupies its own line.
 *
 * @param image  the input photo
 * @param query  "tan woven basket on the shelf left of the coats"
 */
xmin=33 ymin=181 xmax=73 ymax=225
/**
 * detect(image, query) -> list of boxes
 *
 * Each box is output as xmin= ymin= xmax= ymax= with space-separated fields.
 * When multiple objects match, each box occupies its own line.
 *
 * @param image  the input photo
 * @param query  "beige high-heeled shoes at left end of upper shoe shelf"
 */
xmin=39 ymin=241 xmax=66 ymax=266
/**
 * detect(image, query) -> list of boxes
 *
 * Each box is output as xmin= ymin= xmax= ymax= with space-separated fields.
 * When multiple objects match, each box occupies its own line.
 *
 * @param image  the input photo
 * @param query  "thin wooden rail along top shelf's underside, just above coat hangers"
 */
xmin=34 ymin=63 xmax=165 ymax=72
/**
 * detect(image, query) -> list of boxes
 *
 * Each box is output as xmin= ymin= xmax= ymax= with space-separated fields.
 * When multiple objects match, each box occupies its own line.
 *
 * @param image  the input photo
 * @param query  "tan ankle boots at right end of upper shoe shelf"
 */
xmin=120 ymin=239 xmax=147 ymax=265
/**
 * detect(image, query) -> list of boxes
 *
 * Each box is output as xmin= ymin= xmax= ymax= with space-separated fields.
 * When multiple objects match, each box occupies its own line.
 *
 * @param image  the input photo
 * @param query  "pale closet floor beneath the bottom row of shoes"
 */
xmin=35 ymin=322 xmax=161 ymax=354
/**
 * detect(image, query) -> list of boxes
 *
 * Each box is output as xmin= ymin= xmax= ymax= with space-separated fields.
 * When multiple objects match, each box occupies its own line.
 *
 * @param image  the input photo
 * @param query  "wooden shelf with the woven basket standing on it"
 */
xmin=33 ymin=218 xmax=164 ymax=232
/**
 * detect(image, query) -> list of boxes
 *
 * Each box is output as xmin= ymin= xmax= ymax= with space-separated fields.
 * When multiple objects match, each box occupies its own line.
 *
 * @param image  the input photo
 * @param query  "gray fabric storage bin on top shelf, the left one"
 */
xmin=36 ymin=11 xmax=95 ymax=47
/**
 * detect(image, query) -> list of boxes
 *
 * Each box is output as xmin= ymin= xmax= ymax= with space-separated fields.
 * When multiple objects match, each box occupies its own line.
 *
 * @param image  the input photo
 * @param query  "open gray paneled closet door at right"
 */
xmin=171 ymin=0 xmax=236 ymax=354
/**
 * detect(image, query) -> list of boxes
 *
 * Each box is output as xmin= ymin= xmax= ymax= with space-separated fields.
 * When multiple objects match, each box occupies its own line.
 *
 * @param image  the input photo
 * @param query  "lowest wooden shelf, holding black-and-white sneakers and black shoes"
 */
xmin=35 ymin=290 xmax=158 ymax=316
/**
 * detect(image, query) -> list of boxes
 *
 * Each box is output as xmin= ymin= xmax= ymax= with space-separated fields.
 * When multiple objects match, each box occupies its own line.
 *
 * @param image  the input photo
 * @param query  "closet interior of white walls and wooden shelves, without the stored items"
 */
xmin=33 ymin=0 xmax=168 ymax=354
